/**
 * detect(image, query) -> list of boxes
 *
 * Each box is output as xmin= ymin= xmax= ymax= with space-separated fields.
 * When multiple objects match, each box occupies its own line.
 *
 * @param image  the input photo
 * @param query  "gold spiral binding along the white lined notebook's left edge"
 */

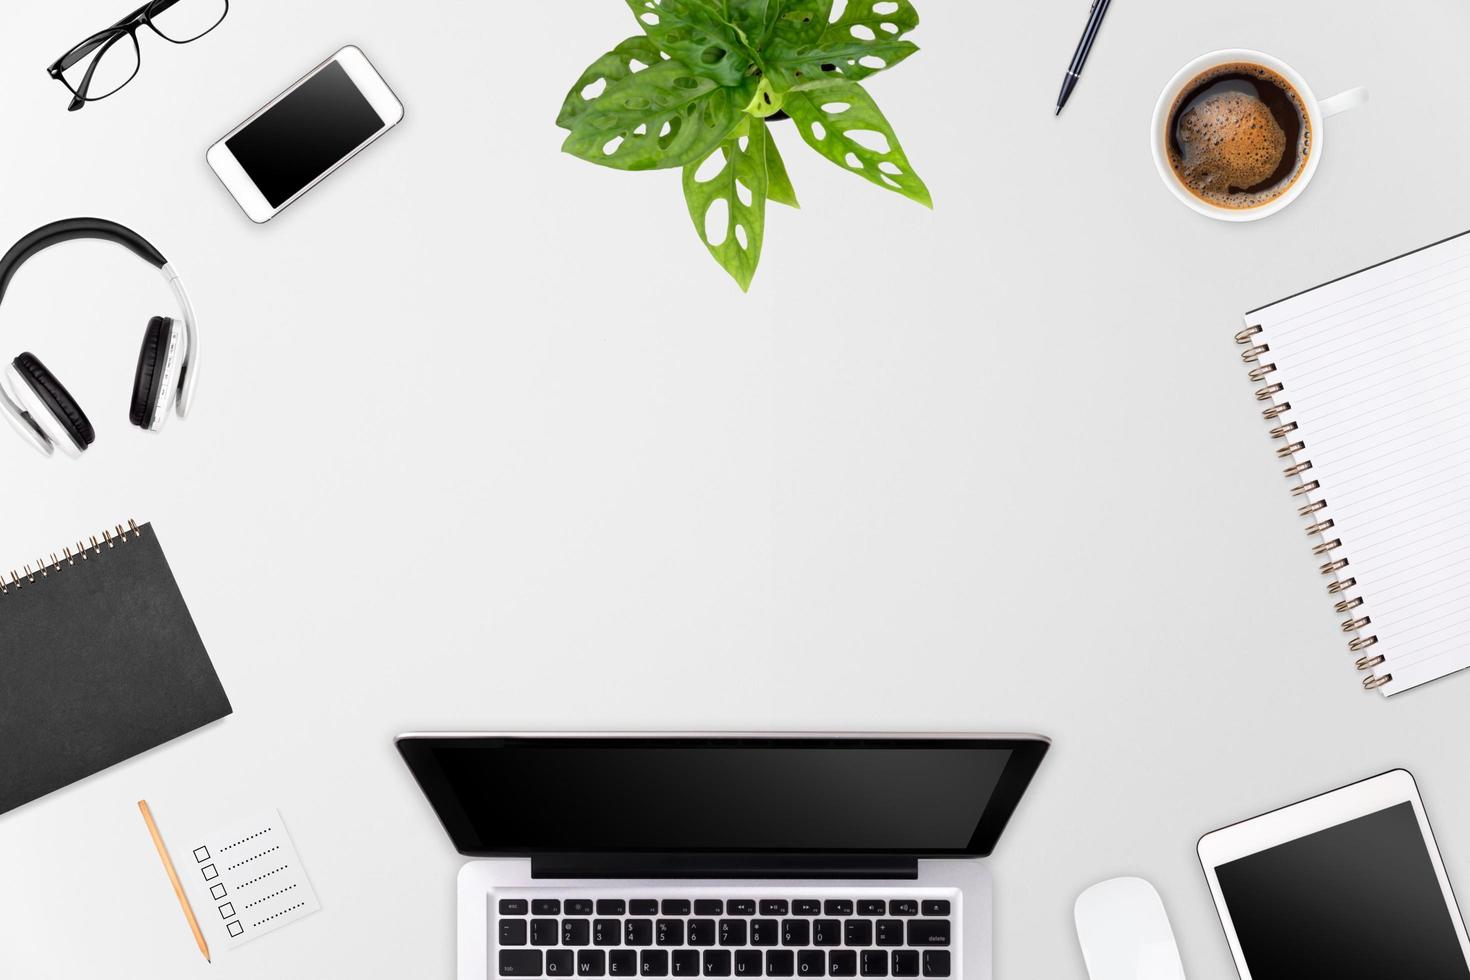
xmin=1235 ymin=323 xmax=1394 ymax=691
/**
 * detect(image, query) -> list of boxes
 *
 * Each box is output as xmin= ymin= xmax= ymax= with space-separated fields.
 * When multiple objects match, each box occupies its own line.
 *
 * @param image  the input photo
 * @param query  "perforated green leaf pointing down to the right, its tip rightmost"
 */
xmin=785 ymin=79 xmax=933 ymax=207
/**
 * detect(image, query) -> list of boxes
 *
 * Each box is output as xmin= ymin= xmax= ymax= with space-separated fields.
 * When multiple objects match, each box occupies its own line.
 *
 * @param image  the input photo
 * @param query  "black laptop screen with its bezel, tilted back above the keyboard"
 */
xmin=398 ymin=736 xmax=1045 ymax=857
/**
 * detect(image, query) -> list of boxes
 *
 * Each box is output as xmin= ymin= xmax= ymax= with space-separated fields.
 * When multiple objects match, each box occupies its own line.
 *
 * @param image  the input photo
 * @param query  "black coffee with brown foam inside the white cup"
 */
xmin=1163 ymin=62 xmax=1311 ymax=209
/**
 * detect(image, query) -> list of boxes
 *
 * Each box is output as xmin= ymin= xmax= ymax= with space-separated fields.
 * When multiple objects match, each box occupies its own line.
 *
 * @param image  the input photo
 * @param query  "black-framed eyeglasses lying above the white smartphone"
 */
xmin=46 ymin=0 xmax=229 ymax=112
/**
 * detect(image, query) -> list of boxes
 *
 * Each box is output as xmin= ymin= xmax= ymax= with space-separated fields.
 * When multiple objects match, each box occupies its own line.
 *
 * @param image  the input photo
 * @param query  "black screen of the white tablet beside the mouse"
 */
xmin=1216 ymin=802 xmax=1470 ymax=980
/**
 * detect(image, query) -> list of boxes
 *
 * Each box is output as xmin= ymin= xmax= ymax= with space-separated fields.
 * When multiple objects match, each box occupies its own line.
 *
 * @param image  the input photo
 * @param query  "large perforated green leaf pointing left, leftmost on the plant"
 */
xmin=562 ymin=60 xmax=745 ymax=170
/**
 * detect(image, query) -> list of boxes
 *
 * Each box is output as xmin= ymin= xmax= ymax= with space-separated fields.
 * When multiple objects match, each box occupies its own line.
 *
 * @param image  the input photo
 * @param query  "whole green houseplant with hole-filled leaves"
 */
xmin=557 ymin=0 xmax=933 ymax=289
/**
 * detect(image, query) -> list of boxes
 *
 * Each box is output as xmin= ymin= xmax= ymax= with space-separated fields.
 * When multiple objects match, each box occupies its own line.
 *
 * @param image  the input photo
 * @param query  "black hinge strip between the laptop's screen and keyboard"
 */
xmin=531 ymin=854 xmax=919 ymax=880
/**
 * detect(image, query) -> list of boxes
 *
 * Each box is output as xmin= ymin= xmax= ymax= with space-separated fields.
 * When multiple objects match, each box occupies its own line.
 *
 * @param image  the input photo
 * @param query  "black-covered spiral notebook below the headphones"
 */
xmin=0 ymin=523 xmax=229 ymax=813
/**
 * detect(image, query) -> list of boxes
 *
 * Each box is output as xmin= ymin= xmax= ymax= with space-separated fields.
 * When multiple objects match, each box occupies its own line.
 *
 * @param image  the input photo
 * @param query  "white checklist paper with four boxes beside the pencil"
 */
xmin=173 ymin=810 xmax=320 ymax=951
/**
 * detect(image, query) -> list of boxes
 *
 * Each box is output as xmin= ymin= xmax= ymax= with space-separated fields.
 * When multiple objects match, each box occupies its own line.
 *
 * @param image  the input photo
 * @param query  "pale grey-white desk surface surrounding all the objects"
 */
xmin=0 ymin=0 xmax=1470 ymax=980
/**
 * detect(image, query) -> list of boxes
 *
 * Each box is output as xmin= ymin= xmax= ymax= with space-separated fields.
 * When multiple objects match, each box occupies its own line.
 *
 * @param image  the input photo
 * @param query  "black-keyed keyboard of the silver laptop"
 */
xmin=491 ymin=895 xmax=956 ymax=980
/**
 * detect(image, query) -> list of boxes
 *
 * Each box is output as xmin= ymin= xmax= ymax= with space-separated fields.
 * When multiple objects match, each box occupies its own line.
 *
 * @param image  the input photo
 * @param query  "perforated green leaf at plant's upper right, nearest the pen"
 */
xmin=761 ymin=0 xmax=919 ymax=88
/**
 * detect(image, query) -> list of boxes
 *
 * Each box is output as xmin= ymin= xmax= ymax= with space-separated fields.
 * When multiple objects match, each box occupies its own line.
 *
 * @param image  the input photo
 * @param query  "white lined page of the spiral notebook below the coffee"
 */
xmin=1245 ymin=227 xmax=1470 ymax=695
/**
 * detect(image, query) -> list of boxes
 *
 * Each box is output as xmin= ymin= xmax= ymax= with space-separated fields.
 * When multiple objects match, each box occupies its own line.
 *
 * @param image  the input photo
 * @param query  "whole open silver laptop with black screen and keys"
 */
xmin=397 ymin=733 xmax=1050 ymax=980
